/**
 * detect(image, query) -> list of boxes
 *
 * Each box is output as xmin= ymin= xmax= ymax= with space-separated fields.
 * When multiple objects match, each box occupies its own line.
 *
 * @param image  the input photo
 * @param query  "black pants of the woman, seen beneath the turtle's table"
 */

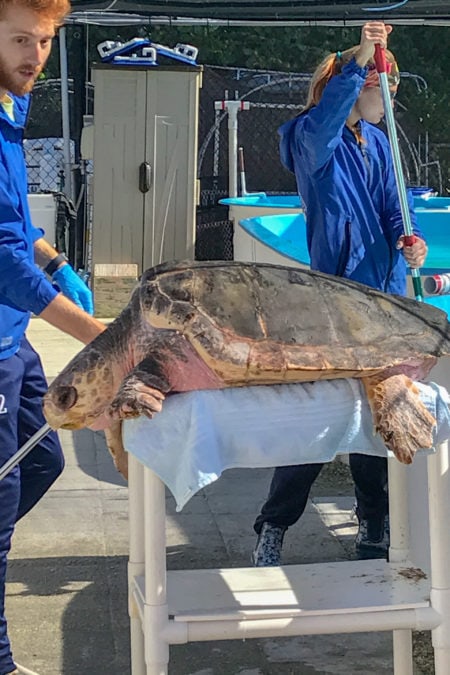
xmin=254 ymin=453 xmax=388 ymax=534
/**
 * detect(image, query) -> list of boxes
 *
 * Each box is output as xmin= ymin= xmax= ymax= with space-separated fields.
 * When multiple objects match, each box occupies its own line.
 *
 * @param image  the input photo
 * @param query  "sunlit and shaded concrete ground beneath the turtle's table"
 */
xmin=7 ymin=318 xmax=426 ymax=675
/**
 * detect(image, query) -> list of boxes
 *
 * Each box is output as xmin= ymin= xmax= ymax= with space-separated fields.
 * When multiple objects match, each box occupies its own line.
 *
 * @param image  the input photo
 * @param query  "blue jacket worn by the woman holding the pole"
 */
xmin=279 ymin=54 xmax=424 ymax=295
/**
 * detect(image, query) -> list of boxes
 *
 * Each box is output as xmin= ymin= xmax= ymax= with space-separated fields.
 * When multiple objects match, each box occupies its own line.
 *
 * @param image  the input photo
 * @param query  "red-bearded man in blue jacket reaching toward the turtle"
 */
xmin=0 ymin=0 xmax=104 ymax=675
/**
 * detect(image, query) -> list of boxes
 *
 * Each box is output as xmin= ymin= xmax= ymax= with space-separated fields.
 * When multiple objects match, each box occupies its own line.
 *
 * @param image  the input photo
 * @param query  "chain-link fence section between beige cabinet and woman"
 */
xmin=196 ymin=67 xmax=309 ymax=260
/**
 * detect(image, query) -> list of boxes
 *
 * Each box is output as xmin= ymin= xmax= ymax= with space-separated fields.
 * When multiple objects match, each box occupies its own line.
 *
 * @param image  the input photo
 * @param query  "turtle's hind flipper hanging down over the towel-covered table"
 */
xmin=363 ymin=374 xmax=436 ymax=464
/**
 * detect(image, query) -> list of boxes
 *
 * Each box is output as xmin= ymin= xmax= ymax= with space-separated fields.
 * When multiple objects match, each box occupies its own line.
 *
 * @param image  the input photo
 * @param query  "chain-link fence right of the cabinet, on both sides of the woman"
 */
xmin=197 ymin=67 xmax=450 ymax=259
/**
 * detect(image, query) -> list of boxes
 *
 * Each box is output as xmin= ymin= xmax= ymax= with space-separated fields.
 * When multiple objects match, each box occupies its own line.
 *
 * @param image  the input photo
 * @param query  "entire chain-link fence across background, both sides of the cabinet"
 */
xmin=25 ymin=66 xmax=450 ymax=260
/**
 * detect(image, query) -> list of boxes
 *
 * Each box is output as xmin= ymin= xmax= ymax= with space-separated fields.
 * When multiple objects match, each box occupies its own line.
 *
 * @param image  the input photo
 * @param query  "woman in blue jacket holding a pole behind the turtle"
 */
xmin=253 ymin=21 xmax=427 ymax=566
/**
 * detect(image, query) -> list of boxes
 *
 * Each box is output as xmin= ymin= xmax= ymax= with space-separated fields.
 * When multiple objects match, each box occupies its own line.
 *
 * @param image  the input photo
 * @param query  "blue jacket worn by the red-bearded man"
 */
xmin=0 ymin=96 xmax=57 ymax=360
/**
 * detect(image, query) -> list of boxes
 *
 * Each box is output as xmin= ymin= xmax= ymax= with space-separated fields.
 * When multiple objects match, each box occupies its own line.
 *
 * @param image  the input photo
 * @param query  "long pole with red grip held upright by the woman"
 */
xmin=375 ymin=45 xmax=423 ymax=301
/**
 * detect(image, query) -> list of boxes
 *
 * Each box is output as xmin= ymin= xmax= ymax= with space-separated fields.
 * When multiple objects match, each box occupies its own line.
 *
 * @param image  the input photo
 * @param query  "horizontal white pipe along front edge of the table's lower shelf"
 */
xmin=162 ymin=607 xmax=438 ymax=644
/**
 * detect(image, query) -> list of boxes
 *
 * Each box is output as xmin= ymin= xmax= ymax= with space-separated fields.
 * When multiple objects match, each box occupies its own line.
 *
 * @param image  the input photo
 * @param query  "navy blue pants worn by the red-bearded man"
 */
xmin=0 ymin=338 xmax=64 ymax=675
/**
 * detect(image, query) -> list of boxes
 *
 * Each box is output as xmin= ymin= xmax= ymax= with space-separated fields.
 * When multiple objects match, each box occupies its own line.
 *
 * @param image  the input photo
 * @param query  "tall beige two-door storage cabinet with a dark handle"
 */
xmin=92 ymin=65 xmax=201 ymax=272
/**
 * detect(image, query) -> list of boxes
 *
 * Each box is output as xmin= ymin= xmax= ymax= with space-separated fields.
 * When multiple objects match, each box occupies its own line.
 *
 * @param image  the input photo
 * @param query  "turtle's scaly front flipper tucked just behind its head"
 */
xmin=107 ymin=358 xmax=170 ymax=420
